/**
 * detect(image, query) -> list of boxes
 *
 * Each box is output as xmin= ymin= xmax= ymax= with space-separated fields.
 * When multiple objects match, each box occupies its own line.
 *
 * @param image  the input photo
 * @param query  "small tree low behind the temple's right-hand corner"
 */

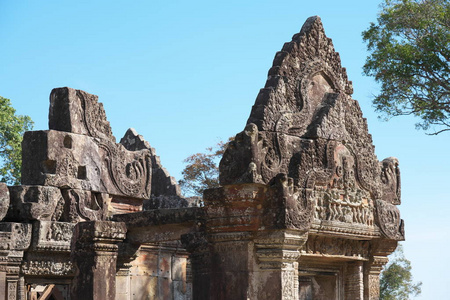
xmin=380 ymin=245 xmax=422 ymax=300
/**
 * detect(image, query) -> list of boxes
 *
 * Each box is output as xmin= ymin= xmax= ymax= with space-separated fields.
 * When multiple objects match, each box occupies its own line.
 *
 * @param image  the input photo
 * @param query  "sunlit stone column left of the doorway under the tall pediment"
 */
xmin=250 ymin=230 xmax=308 ymax=300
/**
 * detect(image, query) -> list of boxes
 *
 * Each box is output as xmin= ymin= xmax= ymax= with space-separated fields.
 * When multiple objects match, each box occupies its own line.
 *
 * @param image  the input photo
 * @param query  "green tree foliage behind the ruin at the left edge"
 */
xmin=0 ymin=96 xmax=33 ymax=184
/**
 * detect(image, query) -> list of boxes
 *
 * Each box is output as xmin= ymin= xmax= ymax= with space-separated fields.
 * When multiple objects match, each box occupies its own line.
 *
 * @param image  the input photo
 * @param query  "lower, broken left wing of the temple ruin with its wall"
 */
xmin=0 ymin=88 xmax=195 ymax=300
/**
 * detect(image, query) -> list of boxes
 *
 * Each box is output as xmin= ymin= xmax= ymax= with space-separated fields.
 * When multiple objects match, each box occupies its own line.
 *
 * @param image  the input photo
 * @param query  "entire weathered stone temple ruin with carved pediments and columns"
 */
xmin=0 ymin=17 xmax=404 ymax=300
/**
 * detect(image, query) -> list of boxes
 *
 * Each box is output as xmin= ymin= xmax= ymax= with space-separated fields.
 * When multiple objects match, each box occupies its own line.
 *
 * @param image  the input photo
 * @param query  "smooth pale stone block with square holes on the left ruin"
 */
xmin=22 ymin=130 xmax=105 ymax=192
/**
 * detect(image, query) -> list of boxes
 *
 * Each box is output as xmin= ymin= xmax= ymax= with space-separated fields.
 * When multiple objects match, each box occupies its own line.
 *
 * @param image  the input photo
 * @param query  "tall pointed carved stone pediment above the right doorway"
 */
xmin=220 ymin=17 xmax=403 ymax=239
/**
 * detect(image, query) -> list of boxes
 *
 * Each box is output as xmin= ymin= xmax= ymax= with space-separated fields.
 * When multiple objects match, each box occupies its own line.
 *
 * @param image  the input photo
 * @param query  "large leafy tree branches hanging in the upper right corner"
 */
xmin=362 ymin=0 xmax=450 ymax=134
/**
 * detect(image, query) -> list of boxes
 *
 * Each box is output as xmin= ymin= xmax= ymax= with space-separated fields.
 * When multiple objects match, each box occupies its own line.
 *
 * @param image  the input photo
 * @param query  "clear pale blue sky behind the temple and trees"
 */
xmin=0 ymin=0 xmax=450 ymax=299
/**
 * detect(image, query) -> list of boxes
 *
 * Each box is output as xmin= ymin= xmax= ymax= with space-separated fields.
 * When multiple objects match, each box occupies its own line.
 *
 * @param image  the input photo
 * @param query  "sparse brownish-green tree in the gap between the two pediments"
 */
xmin=178 ymin=138 xmax=232 ymax=196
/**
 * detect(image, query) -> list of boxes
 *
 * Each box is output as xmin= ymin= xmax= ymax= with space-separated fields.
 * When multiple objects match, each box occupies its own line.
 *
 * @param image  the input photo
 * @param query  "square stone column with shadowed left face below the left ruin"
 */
xmin=71 ymin=221 xmax=127 ymax=300
